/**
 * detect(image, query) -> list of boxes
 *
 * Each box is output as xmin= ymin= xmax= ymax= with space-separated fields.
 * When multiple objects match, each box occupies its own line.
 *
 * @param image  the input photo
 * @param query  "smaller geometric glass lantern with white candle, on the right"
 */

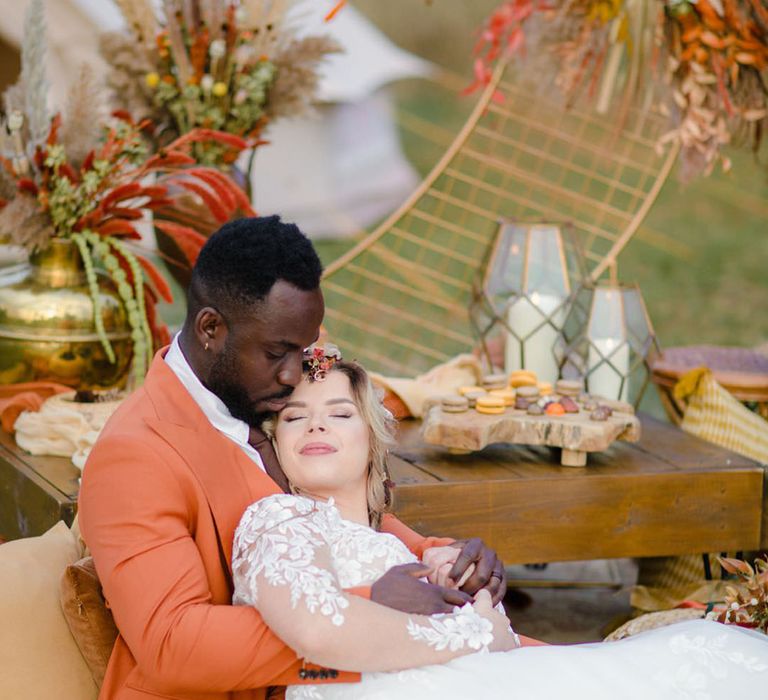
xmin=556 ymin=282 xmax=660 ymax=406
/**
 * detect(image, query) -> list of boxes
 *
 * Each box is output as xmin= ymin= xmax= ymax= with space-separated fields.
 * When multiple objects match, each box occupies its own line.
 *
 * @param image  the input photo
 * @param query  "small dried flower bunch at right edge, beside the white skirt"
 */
xmin=711 ymin=556 xmax=768 ymax=634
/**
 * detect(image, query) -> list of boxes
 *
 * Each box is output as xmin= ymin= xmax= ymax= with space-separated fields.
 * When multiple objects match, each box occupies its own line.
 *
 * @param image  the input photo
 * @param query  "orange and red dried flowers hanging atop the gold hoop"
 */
xmin=467 ymin=0 xmax=768 ymax=179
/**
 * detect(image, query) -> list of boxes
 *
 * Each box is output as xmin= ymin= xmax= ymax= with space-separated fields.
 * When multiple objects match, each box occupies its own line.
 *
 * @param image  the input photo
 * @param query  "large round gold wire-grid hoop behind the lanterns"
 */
xmin=323 ymin=64 xmax=677 ymax=376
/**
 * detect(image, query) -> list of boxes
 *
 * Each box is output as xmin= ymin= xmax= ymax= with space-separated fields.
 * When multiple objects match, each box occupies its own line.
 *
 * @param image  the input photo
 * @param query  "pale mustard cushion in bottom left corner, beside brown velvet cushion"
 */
xmin=0 ymin=522 xmax=97 ymax=700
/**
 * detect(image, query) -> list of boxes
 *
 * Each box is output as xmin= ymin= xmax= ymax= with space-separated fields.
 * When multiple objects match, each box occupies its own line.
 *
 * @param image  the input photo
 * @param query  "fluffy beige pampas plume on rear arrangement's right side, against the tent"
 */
xmin=266 ymin=36 xmax=342 ymax=119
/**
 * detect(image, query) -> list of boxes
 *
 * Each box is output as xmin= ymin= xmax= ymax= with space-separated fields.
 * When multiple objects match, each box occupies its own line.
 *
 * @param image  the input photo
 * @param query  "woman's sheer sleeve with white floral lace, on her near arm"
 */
xmin=233 ymin=494 xmax=512 ymax=671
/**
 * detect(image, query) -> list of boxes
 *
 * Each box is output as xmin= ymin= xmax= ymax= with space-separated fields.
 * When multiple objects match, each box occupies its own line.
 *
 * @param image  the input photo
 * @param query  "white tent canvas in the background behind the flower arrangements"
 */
xmin=0 ymin=0 xmax=433 ymax=236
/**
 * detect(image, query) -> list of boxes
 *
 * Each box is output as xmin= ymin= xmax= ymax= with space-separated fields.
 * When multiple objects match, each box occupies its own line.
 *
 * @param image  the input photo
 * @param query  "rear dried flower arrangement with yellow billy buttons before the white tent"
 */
xmin=101 ymin=0 xmax=340 ymax=172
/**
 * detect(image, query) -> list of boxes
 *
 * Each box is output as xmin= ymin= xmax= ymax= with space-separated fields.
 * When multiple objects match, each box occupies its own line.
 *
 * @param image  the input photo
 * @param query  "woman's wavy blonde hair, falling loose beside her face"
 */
xmin=262 ymin=360 xmax=397 ymax=529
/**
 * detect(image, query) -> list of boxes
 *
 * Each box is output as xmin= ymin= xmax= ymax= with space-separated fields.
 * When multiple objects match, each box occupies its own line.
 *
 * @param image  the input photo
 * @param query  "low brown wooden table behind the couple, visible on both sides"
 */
xmin=0 ymin=416 xmax=768 ymax=563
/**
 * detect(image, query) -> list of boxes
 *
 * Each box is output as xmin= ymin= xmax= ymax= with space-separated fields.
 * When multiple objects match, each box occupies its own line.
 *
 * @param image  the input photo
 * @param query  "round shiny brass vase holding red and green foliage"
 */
xmin=0 ymin=238 xmax=133 ymax=390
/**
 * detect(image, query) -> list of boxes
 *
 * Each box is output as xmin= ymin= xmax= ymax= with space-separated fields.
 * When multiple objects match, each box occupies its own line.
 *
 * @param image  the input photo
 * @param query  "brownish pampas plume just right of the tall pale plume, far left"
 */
xmin=61 ymin=64 xmax=104 ymax=168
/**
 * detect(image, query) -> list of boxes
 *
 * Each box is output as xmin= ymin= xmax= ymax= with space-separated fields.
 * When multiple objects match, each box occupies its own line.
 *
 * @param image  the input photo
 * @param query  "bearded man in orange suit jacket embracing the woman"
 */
xmin=79 ymin=216 xmax=506 ymax=700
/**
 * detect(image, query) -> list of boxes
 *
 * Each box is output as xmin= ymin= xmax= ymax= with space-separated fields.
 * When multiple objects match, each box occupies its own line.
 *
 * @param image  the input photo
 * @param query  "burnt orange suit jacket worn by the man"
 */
xmin=79 ymin=351 xmax=446 ymax=700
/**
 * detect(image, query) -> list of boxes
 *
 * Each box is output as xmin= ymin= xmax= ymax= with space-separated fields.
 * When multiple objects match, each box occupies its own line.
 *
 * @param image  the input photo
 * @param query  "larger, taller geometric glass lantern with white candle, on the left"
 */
xmin=469 ymin=221 xmax=584 ymax=382
